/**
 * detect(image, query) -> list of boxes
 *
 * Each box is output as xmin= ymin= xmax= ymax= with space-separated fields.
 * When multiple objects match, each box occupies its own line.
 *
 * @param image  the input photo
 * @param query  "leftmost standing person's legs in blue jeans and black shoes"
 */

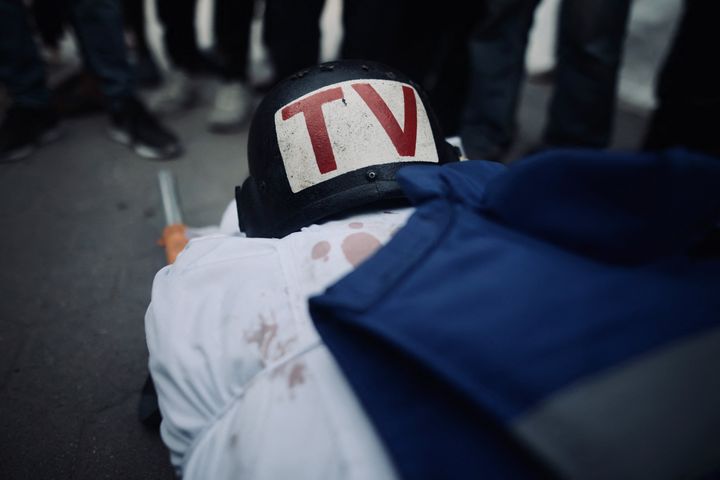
xmin=0 ymin=0 xmax=181 ymax=162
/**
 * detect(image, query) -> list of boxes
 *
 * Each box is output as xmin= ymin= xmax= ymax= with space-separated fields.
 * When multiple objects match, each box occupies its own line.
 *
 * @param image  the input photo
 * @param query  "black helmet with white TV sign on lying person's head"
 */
xmin=235 ymin=61 xmax=458 ymax=238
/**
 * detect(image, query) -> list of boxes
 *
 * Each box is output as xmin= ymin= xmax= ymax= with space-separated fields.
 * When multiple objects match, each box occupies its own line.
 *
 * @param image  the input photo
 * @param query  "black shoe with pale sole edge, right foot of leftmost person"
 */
xmin=110 ymin=97 xmax=182 ymax=160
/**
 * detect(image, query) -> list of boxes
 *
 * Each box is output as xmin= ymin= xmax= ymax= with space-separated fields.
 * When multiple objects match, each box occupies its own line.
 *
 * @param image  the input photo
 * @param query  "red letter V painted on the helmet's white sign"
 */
xmin=352 ymin=83 xmax=417 ymax=157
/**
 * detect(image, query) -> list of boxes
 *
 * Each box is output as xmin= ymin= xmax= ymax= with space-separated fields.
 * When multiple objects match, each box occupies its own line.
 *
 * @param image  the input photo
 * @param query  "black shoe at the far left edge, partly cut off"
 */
xmin=0 ymin=106 xmax=60 ymax=163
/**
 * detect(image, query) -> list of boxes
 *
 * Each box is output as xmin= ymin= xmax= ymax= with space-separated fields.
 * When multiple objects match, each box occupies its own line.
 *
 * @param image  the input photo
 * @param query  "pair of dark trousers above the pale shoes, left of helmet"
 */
xmin=157 ymin=0 xmax=256 ymax=80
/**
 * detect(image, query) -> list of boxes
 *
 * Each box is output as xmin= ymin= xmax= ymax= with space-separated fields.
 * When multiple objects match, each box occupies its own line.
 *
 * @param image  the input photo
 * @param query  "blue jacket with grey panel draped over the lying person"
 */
xmin=310 ymin=150 xmax=720 ymax=479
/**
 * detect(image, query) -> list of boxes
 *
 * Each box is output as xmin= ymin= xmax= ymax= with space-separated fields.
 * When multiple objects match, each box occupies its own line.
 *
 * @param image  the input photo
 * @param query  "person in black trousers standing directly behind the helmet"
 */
xmin=264 ymin=0 xmax=480 ymax=135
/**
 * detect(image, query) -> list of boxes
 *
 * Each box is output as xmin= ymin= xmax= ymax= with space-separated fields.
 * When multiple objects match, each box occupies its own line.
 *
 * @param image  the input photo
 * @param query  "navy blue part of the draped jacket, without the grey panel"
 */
xmin=310 ymin=150 xmax=720 ymax=478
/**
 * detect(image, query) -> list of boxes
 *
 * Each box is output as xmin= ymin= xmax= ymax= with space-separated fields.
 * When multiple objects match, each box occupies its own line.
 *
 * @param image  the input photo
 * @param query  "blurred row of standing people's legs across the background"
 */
xmin=0 ymin=0 xmax=719 ymax=162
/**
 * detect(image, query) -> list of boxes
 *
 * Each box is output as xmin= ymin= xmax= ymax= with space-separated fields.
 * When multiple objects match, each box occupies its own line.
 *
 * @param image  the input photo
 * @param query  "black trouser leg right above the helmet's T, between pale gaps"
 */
xmin=264 ymin=0 xmax=325 ymax=79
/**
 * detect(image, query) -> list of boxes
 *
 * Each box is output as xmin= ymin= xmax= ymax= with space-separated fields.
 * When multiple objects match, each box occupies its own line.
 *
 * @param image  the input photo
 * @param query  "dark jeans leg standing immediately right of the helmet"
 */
xmin=460 ymin=0 xmax=539 ymax=160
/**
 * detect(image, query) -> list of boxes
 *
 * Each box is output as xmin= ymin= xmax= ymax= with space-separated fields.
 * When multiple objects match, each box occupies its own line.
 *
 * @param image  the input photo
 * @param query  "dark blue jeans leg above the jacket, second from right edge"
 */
xmin=545 ymin=0 xmax=630 ymax=148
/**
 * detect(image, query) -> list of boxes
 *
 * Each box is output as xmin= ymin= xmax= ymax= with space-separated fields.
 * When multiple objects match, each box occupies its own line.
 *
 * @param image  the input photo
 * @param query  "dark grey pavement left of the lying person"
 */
xmin=0 ymin=99 xmax=246 ymax=479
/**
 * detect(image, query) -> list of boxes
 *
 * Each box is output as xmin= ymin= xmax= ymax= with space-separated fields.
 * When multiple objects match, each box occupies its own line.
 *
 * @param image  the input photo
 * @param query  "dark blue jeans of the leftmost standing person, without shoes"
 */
xmin=0 ymin=0 xmax=133 ymax=109
